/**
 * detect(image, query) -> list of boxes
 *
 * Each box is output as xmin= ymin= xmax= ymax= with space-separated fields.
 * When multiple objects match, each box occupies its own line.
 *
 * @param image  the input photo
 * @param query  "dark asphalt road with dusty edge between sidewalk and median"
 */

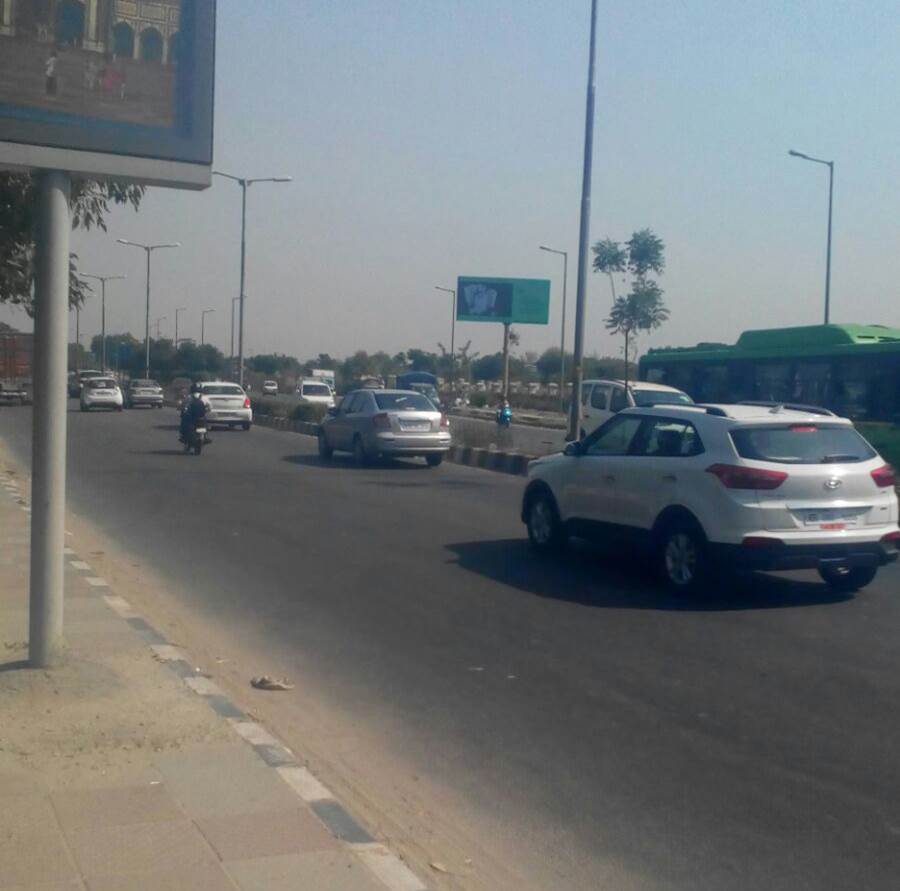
xmin=0 ymin=409 xmax=900 ymax=891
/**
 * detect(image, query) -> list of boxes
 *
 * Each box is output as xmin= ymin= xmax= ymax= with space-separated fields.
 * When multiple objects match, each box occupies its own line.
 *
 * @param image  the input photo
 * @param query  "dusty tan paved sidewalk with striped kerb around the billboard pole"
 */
xmin=0 ymin=470 xmax=425 ymax=891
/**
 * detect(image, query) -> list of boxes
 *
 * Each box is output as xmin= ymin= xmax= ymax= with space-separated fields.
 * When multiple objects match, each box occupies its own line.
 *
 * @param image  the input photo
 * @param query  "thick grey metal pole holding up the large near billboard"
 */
xmin=28 ymin=171 xmax=72 ymax=668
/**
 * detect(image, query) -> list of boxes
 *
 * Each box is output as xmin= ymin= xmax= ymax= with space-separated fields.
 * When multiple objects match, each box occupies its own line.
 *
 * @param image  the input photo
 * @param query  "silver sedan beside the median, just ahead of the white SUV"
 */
xmin=319 ymin=390 xmax=450 ymax=467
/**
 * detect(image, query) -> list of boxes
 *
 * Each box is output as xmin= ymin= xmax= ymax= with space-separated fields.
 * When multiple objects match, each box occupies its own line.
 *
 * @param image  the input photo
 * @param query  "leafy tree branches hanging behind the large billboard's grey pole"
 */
xmin=0 ymin=173 xmax=144 ymax=315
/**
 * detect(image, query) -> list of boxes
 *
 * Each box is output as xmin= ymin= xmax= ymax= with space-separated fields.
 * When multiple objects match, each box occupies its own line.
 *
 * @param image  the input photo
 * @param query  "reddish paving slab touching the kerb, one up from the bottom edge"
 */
xmin=197 ymin=807 xmax=339 ymax=860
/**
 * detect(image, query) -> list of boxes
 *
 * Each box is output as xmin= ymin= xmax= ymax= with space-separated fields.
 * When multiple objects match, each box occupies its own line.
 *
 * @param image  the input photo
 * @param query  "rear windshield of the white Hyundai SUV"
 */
xmin=731 ymin=424 xmax=875 ymax=464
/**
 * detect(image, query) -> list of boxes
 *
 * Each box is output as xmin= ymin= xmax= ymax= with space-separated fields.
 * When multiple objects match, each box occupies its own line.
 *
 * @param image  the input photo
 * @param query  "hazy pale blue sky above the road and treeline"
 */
xmin=0 ymin=0 xmax=900 ymax=357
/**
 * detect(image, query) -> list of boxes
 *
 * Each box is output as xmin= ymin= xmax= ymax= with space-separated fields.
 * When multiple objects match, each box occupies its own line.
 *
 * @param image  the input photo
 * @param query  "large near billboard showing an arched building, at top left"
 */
xmin=0 ymin=0 xmax=215 ymax=187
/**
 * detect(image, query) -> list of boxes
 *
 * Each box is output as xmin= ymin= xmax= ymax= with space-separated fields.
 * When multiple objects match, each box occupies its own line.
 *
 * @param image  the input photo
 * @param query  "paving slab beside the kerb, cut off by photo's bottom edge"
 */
xmin=225 ymin=851 xmax=385 ymax=891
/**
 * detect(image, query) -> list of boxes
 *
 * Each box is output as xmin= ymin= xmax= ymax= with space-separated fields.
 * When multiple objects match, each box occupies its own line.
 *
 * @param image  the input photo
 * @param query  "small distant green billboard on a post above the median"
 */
xmin=456 ymin=276 xmax=550 ymax=325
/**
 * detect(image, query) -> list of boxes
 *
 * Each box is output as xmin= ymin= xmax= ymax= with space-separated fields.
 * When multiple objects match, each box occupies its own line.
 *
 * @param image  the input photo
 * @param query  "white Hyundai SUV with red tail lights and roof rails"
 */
xmin=522 ymin=403 xmax=900 ymax=591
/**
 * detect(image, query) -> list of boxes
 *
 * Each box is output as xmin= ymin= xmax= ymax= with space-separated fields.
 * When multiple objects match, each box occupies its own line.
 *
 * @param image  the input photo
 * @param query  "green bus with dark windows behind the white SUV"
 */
xmin=639 ymin=325 xmax=900 ymax=422
